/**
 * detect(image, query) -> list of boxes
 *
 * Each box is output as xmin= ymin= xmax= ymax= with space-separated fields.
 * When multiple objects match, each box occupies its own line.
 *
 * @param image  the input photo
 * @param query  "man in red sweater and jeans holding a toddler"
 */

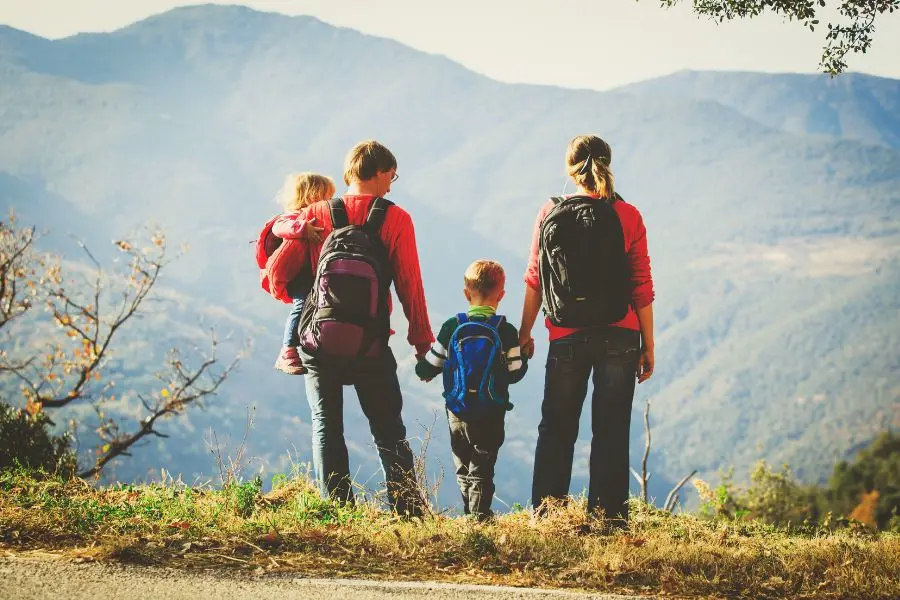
xmin=284 ymin=140 xmax=434 ymax=515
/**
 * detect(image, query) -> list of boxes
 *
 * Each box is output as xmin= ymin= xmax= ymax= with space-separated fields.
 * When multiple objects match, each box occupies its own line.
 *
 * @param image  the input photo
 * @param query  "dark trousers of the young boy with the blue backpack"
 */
xmin=447 ymin=410 xmax=506 ymax=519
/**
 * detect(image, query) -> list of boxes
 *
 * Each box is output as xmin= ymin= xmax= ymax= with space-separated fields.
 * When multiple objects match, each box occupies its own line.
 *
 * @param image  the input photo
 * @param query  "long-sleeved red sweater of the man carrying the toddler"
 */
xmin=270 ymin=195 xmax=434 ymax=354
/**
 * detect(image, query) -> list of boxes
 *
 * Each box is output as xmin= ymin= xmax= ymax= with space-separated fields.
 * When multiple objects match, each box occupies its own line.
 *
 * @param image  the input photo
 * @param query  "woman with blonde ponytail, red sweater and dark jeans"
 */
xmin=519 ymin=136 xmax=654 ymax=526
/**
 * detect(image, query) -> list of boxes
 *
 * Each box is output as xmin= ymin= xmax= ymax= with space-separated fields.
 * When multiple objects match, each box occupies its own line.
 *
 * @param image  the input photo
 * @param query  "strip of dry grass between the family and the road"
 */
xmin=0 ymin=473 xmax=900 ymax=599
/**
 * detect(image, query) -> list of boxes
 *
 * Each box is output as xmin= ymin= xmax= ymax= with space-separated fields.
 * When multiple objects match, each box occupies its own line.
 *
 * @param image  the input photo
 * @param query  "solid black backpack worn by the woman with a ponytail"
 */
xmin=539 ymin=195 xmax=632 ymax=328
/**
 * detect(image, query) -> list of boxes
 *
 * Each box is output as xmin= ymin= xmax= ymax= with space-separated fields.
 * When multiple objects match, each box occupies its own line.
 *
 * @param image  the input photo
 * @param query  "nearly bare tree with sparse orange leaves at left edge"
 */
xmin=0 ymin=215 xmax=241 ymax=477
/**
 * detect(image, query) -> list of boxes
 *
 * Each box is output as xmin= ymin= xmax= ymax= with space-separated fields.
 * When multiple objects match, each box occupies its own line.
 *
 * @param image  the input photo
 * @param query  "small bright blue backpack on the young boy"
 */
xmin=444 ymin=313 xmax=508 ymax=415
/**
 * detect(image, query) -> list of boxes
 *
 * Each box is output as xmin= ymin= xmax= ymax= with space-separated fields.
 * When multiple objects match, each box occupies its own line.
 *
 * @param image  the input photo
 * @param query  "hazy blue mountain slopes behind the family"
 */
xmin=0 ymin=6 xmax=900 ymax=502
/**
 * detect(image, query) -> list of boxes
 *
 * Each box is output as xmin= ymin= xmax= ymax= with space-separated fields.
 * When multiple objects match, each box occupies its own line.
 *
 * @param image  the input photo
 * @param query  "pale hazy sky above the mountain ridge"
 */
xmin=0 ymin=0 xmax=900 ymax=89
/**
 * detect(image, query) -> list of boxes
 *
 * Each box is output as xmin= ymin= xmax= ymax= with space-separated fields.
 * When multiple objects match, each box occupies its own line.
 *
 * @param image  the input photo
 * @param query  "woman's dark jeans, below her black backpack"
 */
xmin=531 ymin=327 xmax=640 ymax=522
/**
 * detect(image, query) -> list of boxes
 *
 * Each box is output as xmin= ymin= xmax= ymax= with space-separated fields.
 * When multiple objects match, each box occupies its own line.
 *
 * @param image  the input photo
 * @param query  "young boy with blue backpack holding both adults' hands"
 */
xmin=416 ymin=260 xmax=528 ymax=520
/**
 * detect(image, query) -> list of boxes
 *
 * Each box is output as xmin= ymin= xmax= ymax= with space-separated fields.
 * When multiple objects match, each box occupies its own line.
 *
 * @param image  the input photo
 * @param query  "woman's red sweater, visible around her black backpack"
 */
xmin=525 ymin=195 xmax=654 ymax=342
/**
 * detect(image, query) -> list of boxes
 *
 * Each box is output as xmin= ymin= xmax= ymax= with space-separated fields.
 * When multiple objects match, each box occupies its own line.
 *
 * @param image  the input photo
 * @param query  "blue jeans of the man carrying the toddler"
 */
xmin=300 ymin=349 xmax=421 ymax=516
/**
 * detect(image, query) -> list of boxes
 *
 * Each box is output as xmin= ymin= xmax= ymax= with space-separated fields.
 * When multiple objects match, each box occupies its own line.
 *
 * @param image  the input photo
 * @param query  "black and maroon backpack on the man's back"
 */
xmin=298 ymin=198 xmax=393 ymax=358
